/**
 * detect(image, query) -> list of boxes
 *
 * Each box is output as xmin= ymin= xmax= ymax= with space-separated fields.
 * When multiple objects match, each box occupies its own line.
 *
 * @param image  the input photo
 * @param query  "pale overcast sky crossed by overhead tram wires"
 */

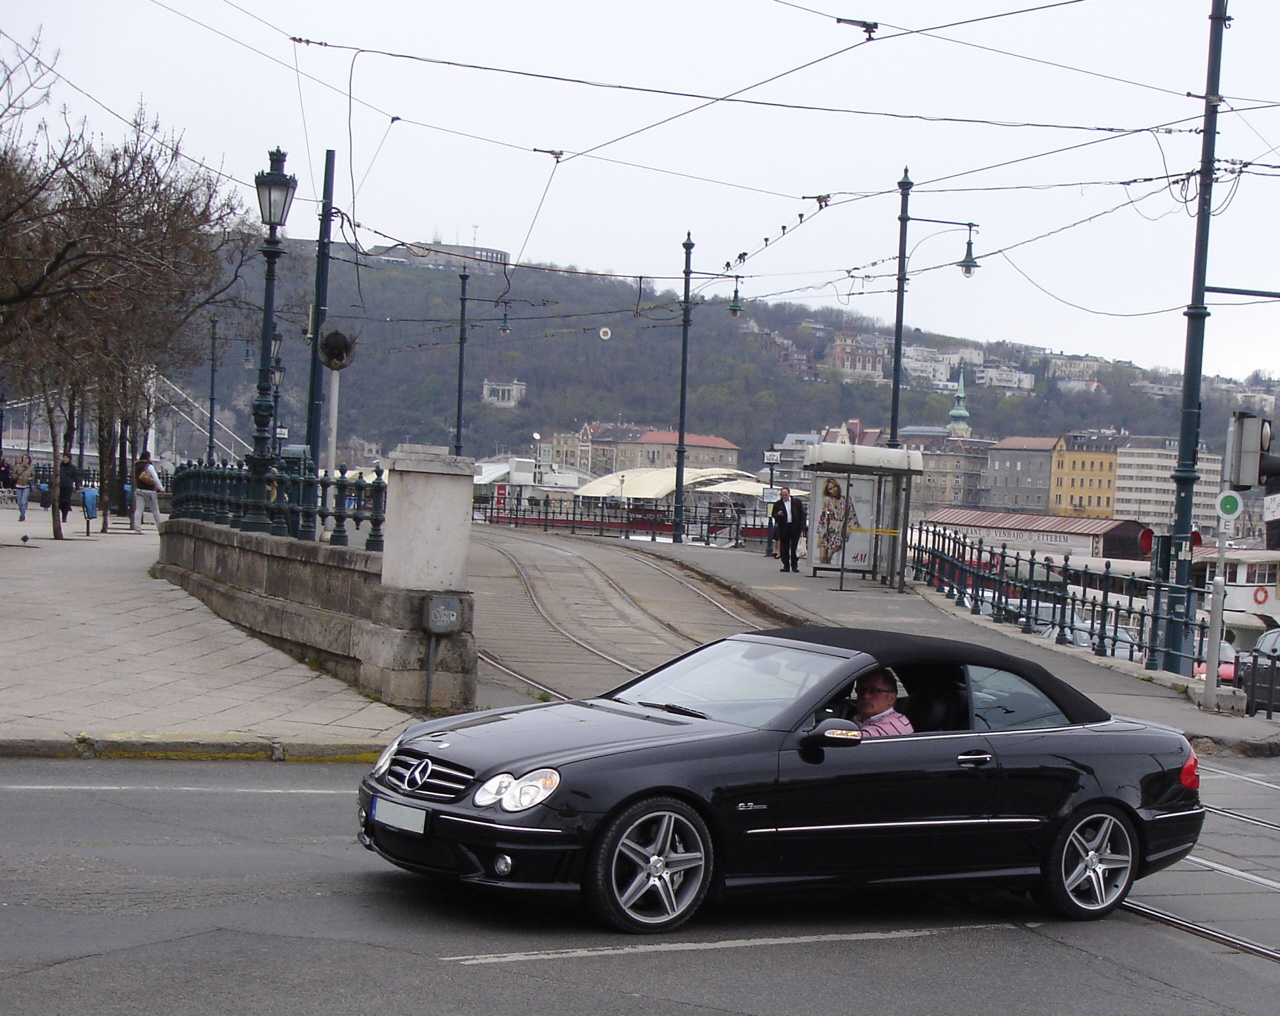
xmin=0 ymin=0 xmax=1280 ymax=377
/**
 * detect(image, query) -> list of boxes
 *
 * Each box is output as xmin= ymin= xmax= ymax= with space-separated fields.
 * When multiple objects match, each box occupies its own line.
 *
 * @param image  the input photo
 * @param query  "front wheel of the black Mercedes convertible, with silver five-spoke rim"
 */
xmin=582 ymin=797 xmax=714 ymax=934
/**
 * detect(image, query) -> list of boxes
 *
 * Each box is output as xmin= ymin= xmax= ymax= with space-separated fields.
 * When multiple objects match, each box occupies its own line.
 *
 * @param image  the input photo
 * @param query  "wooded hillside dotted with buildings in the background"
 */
xmin=192 ymin=243 xmax=1254 ymax=468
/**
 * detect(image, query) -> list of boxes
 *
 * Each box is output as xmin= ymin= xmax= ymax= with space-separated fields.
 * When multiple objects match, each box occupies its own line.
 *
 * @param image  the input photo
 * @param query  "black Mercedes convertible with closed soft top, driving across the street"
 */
xmin=358 ymin=627 xmax=1204 ymax=932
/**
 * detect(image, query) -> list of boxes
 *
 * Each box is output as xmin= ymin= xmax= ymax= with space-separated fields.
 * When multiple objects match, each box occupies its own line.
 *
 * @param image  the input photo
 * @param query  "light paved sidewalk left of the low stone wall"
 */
xmin=0 ymin=507 xmax=410 ymax=761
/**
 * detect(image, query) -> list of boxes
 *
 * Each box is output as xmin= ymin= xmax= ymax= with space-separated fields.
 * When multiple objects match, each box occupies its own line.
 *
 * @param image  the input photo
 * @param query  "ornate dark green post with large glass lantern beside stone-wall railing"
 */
xmin=241 ymin=148 xmax=298 ymax=532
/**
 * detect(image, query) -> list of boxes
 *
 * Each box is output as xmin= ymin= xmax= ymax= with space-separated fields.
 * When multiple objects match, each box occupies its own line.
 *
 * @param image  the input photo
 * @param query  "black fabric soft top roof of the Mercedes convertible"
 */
xmin=754 ymin=626 xmax=1111 ymax=723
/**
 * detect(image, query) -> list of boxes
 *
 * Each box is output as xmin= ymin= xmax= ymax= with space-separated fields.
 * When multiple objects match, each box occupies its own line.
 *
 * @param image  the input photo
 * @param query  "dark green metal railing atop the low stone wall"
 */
xmin=169 ymin=458 xmax=387 ymax=550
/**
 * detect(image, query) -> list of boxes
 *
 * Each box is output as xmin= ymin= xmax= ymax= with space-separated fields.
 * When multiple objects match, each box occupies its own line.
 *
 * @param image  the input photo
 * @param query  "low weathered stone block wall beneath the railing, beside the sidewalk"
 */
xmin=156 ymin=519 xmax=476 ymax=710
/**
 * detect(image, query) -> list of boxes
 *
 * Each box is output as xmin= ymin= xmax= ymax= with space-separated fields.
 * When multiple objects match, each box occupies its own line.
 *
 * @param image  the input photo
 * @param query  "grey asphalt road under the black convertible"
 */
xmin=0 ymin=759 xmax=1280 ymax=1016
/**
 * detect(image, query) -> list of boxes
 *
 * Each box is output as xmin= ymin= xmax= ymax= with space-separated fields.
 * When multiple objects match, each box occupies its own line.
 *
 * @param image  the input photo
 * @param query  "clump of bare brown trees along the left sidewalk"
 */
xmin=0 ymin=35 xmax=257 ymax=539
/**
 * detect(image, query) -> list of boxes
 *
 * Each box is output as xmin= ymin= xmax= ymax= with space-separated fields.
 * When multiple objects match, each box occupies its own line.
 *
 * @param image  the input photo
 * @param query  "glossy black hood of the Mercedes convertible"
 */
xmin=403 ymin=699 xmax=748 ymax=775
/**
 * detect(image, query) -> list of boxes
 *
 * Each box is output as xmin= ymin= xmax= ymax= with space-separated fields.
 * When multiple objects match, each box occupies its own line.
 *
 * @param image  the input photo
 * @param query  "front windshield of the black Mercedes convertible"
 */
xmin=607 ymin=640 xmax=847 ymax=727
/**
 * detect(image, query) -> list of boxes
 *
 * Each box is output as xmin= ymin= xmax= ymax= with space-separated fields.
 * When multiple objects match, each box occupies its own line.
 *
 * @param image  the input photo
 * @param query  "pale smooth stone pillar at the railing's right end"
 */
xmin=383 ymin=444 xmax=476 ymax=592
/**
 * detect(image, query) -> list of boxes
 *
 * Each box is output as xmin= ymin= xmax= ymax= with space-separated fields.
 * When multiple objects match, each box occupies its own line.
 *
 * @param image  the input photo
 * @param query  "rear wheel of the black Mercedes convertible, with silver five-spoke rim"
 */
xmin=1033 ymin=805 xmax=1138 ymax=921
